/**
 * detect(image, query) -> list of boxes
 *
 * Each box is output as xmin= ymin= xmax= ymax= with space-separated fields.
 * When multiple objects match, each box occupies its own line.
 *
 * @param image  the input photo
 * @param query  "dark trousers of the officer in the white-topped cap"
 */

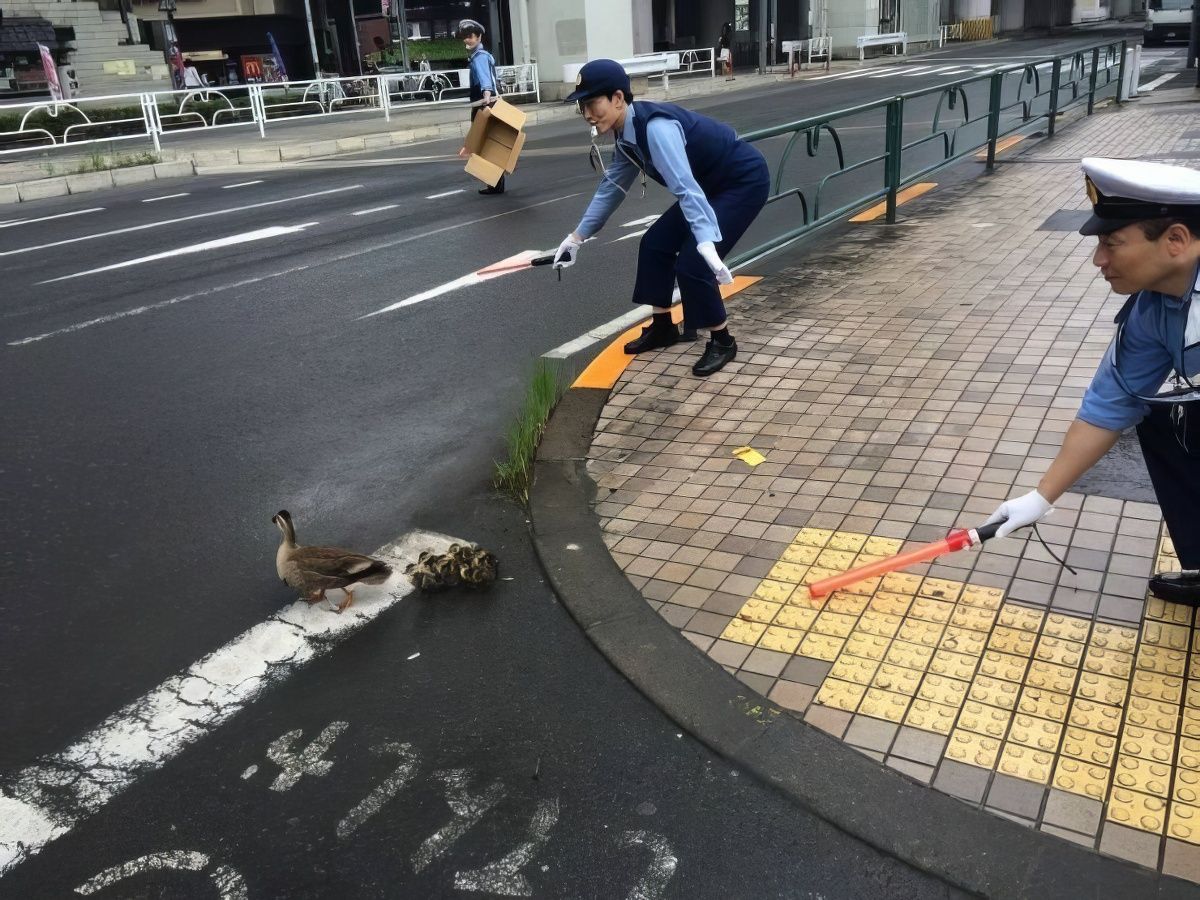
xmin=1138 ymin=404 xmax=1200 ymax=569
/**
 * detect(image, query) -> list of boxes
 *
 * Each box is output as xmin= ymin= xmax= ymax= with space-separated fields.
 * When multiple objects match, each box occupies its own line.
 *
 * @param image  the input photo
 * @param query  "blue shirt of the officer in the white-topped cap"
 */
xmin=1079 ymin=262 xmax=1200 ymax=431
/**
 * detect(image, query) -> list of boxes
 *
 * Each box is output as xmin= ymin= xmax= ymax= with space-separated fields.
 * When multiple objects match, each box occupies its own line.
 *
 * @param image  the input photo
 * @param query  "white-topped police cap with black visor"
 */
xmin=1079 ymin=157 xmax=1200 ymax=235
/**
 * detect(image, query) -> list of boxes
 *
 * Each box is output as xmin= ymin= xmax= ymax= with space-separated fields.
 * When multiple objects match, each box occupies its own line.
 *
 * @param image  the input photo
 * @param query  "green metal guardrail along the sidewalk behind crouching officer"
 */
xmin=730 ymin=41 xmax=1126 ymax=266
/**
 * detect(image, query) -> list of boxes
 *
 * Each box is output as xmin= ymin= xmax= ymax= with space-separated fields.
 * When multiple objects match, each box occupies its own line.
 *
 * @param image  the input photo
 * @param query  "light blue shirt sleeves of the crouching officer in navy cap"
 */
xmin=575 ymin=101 xmax=721 ymax=244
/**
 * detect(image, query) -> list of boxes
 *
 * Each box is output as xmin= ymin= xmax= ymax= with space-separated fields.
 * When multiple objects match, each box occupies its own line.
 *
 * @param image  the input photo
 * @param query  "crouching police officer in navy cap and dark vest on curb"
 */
xmin=554 ymin=59 xmax=770 ymax=377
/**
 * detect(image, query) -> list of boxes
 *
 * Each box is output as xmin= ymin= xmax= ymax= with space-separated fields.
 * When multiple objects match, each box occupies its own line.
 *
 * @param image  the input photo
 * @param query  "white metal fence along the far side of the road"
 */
xmin=0 ymin=64 xmax=541 ymax=155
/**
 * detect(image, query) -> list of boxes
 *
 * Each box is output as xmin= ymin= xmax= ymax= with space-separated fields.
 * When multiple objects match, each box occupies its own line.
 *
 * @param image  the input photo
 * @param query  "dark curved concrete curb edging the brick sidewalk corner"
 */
xmin=529 ymin=389 xmax=1196 ymax=899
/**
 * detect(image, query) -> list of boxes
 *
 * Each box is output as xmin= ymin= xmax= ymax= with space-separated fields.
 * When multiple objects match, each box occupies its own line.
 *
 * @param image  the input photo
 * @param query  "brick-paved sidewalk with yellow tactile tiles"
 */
xmin=589 ymin=92 xmax=1200 ymax=881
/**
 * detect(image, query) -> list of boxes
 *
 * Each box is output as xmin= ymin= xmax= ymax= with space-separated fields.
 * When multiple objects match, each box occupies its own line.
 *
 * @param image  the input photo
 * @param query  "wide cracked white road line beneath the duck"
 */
xmin=0 ymin=532 xmax=451 ymax=876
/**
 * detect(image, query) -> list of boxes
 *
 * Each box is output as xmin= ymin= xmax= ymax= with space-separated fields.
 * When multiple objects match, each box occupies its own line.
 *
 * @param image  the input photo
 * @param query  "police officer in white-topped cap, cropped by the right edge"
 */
xmin=989 ymin=160 xmax=1200 ymax=605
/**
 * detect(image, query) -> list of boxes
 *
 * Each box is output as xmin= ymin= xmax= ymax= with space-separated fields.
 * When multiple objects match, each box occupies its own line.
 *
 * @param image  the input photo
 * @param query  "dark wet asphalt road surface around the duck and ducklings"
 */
xmin=0 ymin=28 xmax=1142 ymax=898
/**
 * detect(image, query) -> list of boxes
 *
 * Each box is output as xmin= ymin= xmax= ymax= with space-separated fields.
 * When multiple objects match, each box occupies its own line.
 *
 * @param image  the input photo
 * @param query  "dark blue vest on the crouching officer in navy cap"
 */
xmin=634 ymin=100 xmax=767 ymax=193
